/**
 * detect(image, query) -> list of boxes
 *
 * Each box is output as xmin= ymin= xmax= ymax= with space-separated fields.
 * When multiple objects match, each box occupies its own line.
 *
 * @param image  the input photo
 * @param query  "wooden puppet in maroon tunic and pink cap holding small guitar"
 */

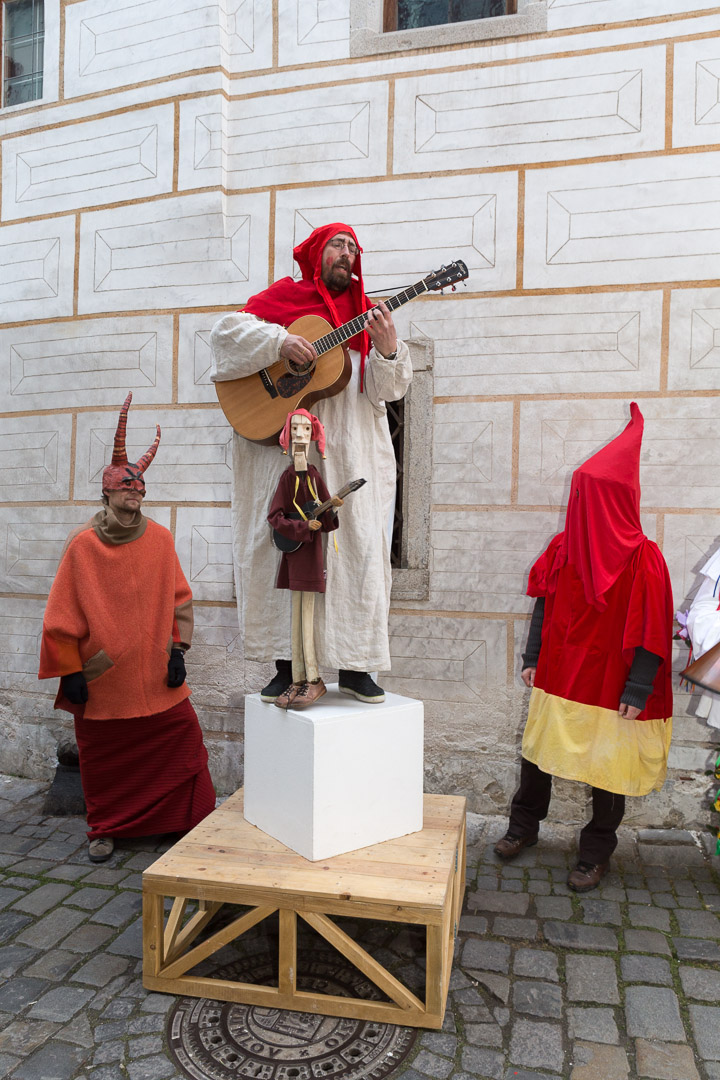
xmin=268 ymin=408 xmax=343 ymax=708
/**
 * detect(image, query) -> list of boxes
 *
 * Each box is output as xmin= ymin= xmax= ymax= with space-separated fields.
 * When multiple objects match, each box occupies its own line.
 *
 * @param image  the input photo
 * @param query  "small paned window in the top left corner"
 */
xmin=2 ymin=0 xmax=45 ymax=106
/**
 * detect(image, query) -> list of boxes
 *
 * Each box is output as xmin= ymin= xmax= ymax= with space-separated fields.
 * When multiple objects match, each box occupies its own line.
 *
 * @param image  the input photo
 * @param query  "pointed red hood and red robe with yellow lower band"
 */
xmin=522 ymin=402 xmax=673 ymax=795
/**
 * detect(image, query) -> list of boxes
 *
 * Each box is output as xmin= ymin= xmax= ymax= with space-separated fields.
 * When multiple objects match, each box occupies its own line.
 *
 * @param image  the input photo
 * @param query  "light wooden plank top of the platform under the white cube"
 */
xmin=142 ymin=788 xmax=465 ymax=912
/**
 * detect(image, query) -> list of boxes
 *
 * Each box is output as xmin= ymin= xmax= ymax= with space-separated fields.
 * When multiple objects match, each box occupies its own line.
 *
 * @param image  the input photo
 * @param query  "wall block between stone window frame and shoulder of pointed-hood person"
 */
xmin=427 ymin=510 xmax=565 ymax=613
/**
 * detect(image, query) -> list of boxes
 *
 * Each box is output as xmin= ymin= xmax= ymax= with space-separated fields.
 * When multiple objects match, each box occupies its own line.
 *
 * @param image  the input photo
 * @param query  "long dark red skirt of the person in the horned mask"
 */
xmin=74 ymin=698 xmax=215 ymax=840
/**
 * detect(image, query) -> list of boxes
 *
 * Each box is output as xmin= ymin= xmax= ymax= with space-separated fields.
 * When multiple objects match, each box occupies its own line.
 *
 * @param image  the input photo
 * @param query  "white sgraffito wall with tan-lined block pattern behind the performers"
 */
xmin=0 ymin=0 xmax=720 ymax=826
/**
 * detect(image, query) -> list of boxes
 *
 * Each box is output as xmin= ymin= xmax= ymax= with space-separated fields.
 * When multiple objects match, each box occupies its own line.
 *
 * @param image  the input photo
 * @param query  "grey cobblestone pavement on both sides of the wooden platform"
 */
xmin=0 ymin=777 xmax=720 ymax=1080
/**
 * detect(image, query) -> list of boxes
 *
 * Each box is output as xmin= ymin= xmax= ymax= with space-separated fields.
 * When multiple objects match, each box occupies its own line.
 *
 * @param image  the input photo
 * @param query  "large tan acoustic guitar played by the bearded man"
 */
xmin=215 ymin=259 xmax=467 ymax=445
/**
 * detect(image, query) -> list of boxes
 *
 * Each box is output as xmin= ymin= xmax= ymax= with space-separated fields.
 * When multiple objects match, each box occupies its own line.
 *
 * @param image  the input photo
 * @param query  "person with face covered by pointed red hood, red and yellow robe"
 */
xmin=494 ymin=402 xmax=673 ymax=892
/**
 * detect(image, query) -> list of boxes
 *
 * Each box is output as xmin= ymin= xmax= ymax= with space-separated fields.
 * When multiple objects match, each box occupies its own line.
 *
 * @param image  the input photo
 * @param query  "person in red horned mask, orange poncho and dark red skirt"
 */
xmin=38 ymin=393 xmax=215 ymax=862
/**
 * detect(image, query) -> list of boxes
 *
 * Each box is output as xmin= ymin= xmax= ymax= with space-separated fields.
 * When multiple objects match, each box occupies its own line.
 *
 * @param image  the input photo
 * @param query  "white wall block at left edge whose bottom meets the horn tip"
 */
xmin=0 ymin=315 xmax=173 ymax=411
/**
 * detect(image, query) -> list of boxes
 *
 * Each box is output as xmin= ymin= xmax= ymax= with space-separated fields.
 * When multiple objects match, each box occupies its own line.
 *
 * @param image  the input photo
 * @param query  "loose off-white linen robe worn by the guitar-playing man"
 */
xmin=210 ymin=312 xmax=412 ymax=671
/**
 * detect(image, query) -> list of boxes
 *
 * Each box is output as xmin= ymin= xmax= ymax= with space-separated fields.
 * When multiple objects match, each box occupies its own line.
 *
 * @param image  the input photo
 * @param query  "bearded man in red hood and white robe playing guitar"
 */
xmin=210 ymin=221 xmax=412 ymax=702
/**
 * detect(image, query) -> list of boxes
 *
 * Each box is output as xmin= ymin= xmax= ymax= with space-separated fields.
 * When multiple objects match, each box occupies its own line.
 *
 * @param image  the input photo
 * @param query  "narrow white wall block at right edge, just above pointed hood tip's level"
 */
xmin=667 ymin=288 xmax=720 ymax=390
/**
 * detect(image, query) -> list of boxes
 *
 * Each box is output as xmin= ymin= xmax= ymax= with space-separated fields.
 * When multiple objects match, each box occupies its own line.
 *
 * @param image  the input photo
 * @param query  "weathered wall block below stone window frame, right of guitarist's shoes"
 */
xmin=383 ymin=613 xmax=507 ymax=702
